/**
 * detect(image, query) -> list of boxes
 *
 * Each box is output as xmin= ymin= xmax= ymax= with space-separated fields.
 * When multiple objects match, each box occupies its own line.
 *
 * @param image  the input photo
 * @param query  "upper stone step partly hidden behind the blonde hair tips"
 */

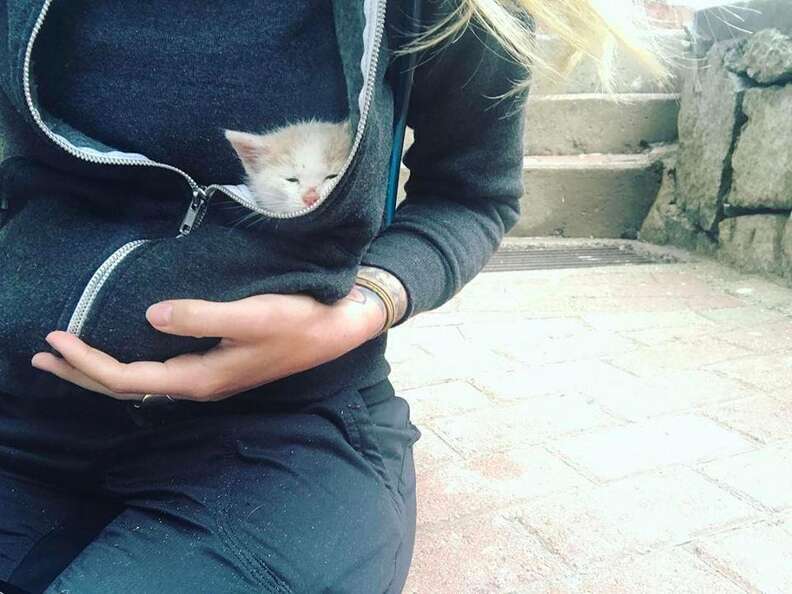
xmin=531 ymin=29 xmax=690 ymax=95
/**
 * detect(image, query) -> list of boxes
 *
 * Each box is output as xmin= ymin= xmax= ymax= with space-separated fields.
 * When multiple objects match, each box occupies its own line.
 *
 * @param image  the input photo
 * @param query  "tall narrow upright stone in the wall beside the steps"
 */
xmin=677 ymin=44 xmax=746 ymax=232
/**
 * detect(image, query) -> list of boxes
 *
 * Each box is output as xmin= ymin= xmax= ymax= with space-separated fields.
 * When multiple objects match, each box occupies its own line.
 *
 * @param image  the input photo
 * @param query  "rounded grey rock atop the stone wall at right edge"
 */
xmin=725 ymin=29 xmax=792 ymax=85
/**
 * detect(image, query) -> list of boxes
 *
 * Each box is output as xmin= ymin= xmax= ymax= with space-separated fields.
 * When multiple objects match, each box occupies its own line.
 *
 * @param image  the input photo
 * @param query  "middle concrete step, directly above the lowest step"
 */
xmin=525 ymin=93 xmax=679 ymax=155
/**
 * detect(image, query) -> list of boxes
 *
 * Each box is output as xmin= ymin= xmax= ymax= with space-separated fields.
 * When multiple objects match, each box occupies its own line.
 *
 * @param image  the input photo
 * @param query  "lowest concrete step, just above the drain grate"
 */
xmin=510 ymin=147 xmax=669 ymax=239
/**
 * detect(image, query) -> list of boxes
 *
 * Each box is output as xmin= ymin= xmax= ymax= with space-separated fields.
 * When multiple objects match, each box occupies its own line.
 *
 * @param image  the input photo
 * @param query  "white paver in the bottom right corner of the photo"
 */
xmin=694 ymin=524 xmax=792 ymax=594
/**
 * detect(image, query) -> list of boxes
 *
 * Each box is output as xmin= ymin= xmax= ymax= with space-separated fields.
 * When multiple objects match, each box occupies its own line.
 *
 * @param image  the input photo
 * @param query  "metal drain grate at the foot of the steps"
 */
xmin=484 ymin=245 xmax=668 ymax=272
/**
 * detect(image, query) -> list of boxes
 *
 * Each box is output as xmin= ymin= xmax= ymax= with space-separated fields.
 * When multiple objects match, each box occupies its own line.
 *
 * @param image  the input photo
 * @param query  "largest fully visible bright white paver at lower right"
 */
xmin=553 ymin=415 xmax=754 ymax=480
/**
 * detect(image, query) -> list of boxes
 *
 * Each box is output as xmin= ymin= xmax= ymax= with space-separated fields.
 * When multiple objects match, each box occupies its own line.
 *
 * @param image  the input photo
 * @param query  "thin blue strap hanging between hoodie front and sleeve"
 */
xmin=384 ymin=0 xmax=422 ymax=227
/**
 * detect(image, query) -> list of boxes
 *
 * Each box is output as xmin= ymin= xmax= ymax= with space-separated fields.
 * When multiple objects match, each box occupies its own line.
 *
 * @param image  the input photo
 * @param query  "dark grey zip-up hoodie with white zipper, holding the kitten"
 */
xmin=0 ymin=0 xmax=525 ymax=400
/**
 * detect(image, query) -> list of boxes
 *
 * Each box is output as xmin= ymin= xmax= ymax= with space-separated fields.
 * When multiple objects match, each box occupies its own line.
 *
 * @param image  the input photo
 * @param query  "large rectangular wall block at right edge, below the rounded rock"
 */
xmin=728 ymin=85 xmax=792 ymax=210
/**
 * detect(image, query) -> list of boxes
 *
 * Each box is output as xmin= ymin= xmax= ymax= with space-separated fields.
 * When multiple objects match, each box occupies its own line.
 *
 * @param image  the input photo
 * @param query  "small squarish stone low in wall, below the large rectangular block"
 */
xmin=719 ymin=213 xmax=789 ymax=274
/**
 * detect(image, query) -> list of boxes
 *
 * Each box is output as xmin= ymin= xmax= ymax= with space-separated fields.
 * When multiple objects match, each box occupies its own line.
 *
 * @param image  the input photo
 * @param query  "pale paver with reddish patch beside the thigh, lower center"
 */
xmin=417 ymin=441 xmax=591 ymax=526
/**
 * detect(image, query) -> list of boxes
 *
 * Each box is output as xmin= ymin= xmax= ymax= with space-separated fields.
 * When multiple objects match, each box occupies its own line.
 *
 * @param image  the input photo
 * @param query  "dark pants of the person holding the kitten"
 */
xmin=0 ymin=382 xmax=419 ymax=594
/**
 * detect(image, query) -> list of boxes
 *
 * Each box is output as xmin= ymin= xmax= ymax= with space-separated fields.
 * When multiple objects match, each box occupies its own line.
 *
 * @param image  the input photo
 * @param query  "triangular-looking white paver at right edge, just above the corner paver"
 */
xmin=702 ymin=441 xmax=792 ymax=511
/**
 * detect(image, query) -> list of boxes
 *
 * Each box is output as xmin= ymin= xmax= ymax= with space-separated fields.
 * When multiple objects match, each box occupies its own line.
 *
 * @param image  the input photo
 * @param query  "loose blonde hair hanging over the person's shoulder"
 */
xmin=408 ymin=0 xmax=671 ymax=91
